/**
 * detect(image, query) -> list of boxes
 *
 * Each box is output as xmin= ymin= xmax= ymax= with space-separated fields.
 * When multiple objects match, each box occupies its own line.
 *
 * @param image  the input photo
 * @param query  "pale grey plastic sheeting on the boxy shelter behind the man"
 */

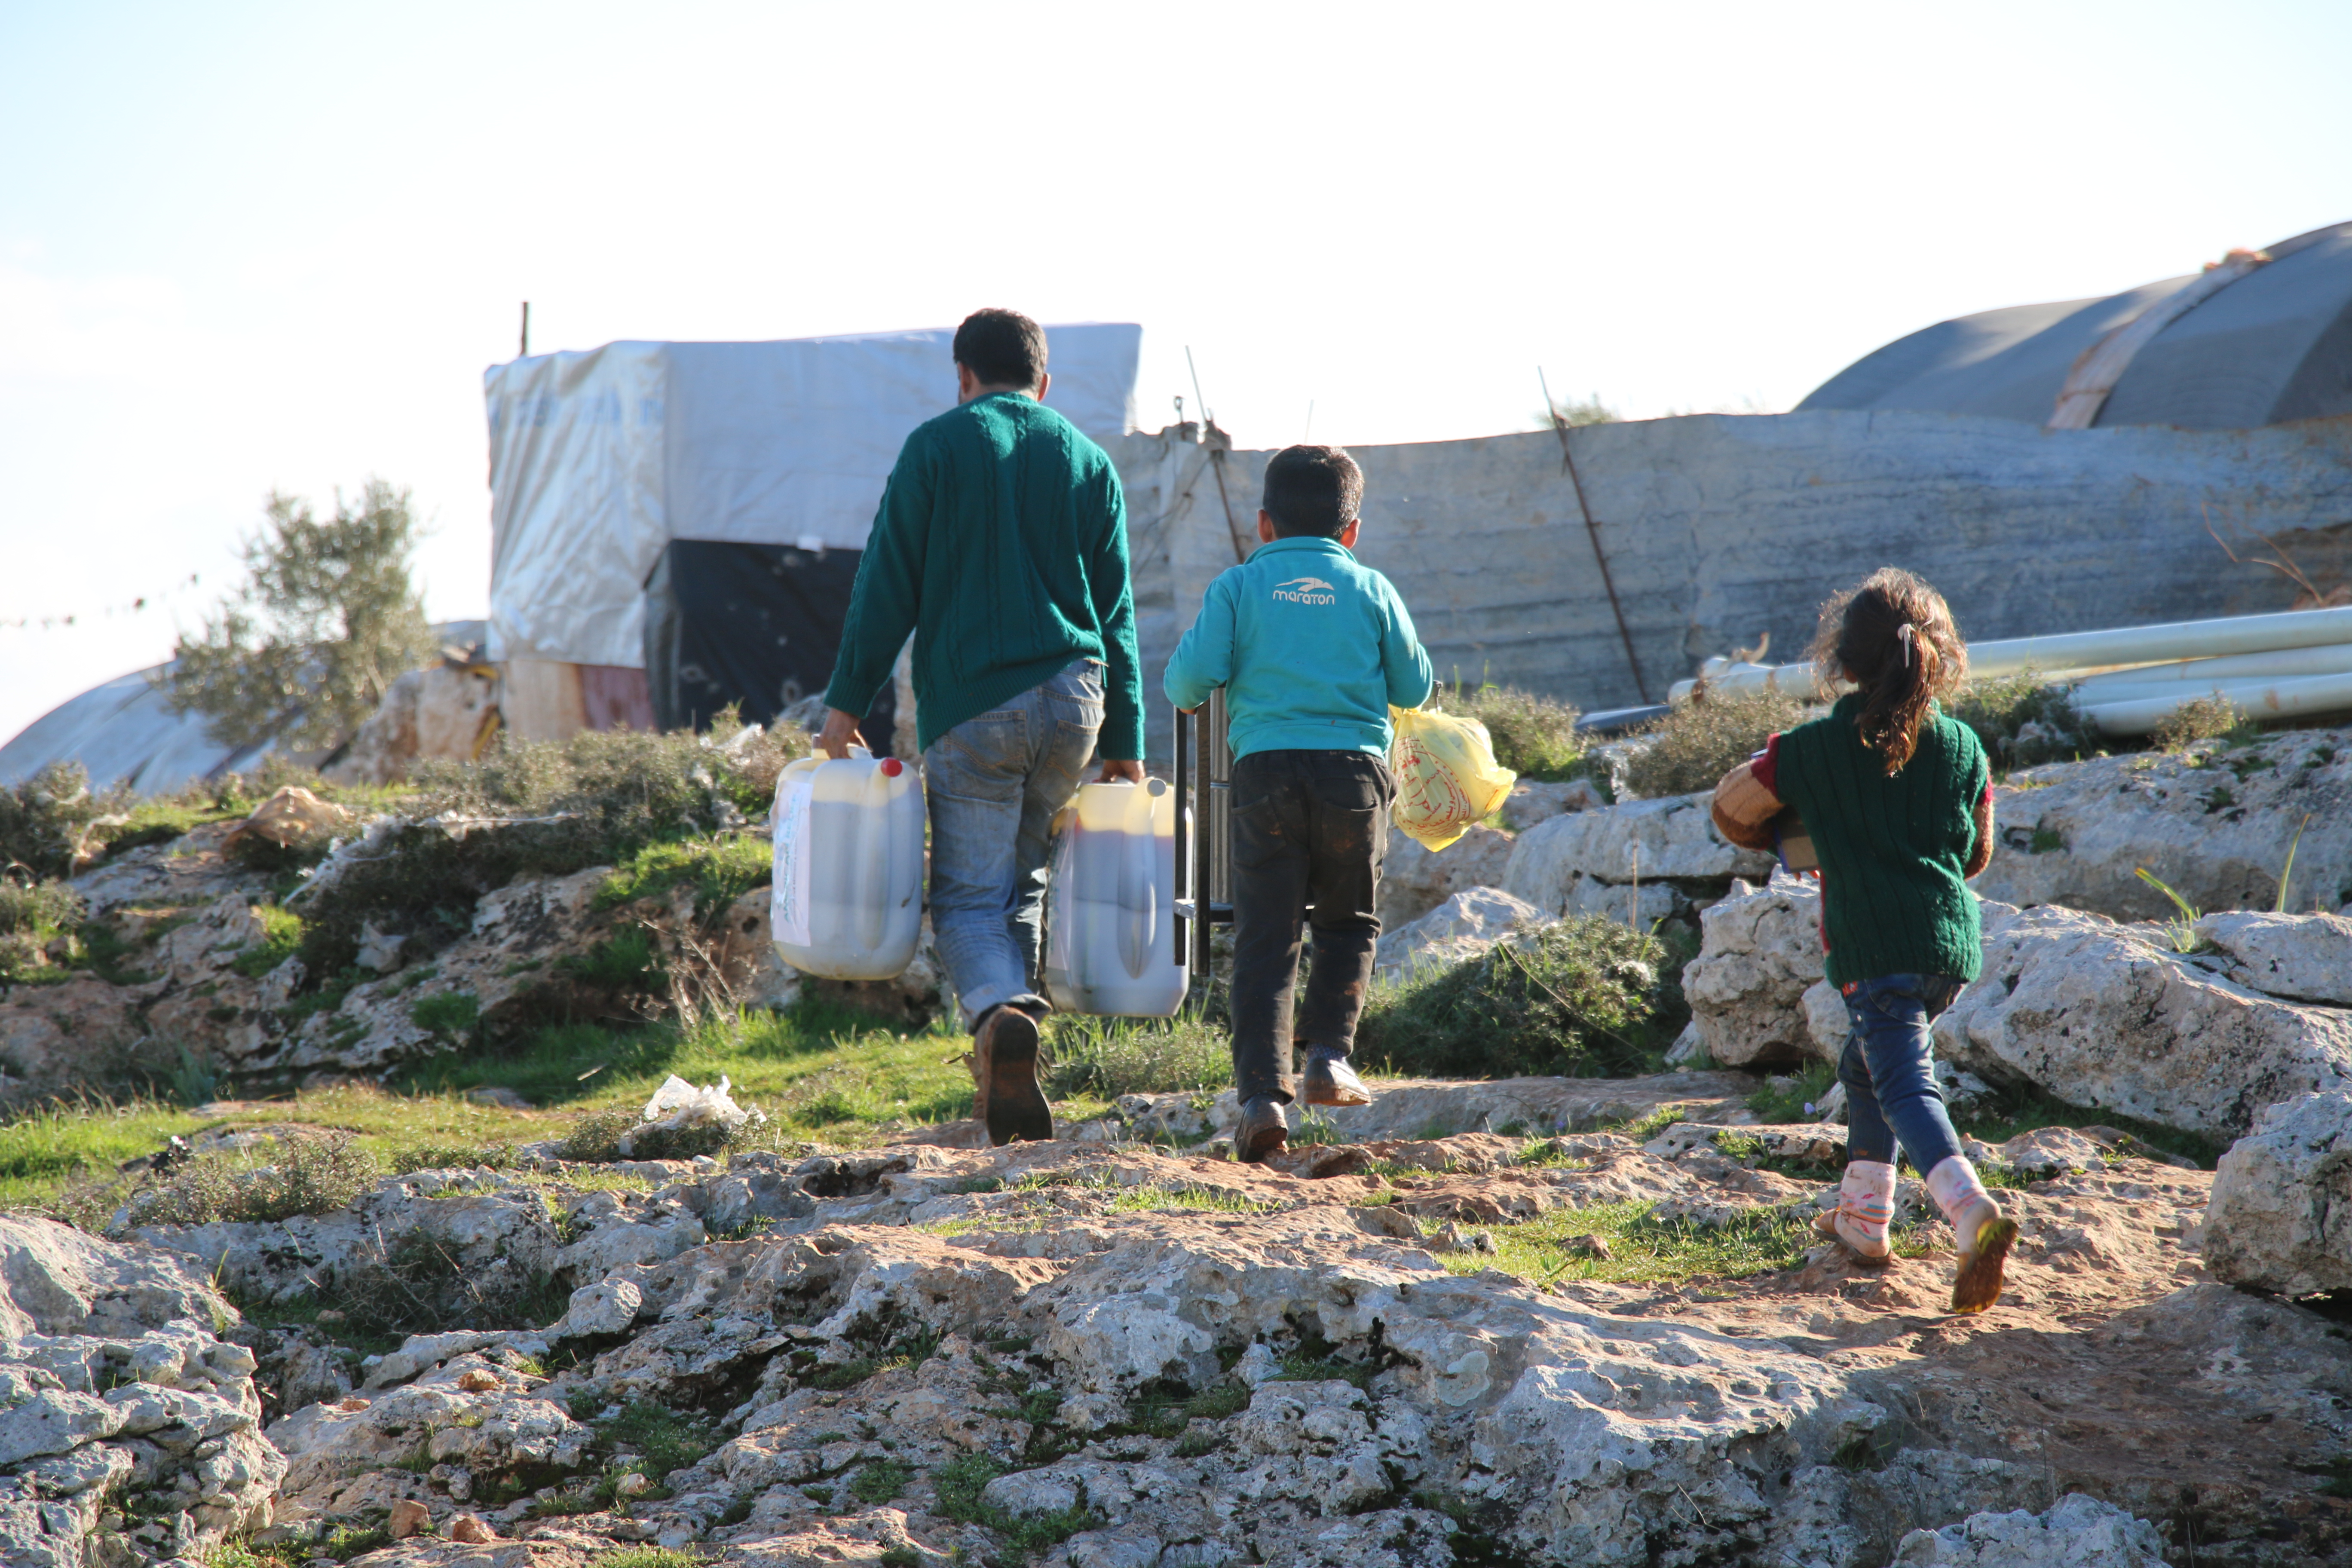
xmin=482 ymin=325 xmax=1143 ymax=668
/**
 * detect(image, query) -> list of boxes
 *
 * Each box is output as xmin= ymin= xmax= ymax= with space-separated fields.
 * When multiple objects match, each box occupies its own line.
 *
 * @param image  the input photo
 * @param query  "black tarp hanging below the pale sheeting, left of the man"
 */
xmin=644 ymin=538 xmax=898 ymax=752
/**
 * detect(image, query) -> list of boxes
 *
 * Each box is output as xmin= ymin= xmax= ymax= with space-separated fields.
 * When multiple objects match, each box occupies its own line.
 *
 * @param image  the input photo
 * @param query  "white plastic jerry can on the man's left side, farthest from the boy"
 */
xmin=769 ymin=745 xmax=922 ymax=980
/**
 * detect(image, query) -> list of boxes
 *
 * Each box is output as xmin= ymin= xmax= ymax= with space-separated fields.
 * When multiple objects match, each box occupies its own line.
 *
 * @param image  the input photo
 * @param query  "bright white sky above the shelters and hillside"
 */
xmin=0 ymin=0 xmax=2352 ymax=738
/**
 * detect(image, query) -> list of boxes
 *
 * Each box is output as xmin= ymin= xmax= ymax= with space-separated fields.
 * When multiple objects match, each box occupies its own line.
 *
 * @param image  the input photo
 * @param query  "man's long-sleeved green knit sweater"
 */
xmin=826 ymin=392 xmax=1143 ymax=760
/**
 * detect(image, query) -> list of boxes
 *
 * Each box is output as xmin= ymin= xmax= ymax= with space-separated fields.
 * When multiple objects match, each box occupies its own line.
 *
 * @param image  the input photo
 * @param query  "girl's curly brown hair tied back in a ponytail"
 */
xmin=1813 ymin=567 xmax=1969 ymax=778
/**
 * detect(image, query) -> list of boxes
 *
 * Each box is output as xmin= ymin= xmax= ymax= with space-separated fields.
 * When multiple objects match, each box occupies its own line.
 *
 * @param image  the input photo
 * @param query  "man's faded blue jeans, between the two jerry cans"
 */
xmin=922 ymin=658 xmax=1103 ymax=1025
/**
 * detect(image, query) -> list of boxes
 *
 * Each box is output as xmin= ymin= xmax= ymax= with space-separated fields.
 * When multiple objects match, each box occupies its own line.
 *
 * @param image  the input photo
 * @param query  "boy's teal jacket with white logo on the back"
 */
xmin=1162 ymin=536 xmax=1430 ymax=757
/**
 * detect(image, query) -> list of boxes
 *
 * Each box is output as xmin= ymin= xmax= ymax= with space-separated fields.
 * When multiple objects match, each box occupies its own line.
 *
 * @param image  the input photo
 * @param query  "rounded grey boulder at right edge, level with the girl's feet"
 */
xmin=2204 ymin=1091 xmax=2352 ymax=1295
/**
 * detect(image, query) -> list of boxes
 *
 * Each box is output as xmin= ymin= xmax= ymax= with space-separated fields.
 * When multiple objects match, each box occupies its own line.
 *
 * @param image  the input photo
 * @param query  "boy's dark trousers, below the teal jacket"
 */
xmin=1232 ymin=752 xmax=1397 ymax=1105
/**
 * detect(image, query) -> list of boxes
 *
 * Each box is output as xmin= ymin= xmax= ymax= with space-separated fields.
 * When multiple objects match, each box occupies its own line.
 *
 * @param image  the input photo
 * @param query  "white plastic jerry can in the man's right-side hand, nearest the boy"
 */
xmin=1044 ymin=778 xmax=1190 ymax=1018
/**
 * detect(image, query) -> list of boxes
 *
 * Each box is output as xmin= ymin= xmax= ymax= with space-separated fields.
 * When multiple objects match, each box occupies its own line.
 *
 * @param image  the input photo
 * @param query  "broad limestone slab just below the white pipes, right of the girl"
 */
xmin=1975 ymin=731 xmax=2352 ymax=919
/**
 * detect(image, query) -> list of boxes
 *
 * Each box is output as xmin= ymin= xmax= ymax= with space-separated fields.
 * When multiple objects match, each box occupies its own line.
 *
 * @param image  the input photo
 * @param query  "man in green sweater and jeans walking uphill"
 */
xmin=818 ymin=310 xmax=1143 ymax=1142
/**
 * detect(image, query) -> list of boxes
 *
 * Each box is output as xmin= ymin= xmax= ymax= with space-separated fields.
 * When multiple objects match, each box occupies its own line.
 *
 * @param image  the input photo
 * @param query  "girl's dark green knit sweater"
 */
xmin=1773 ymin=693 xmax=1990 ymax=985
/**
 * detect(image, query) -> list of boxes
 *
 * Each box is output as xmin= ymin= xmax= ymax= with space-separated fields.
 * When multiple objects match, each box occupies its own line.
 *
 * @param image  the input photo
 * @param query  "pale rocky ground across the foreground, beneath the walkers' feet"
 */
xmin=0 ymin=1074 xmax=2352 ymax=1568
